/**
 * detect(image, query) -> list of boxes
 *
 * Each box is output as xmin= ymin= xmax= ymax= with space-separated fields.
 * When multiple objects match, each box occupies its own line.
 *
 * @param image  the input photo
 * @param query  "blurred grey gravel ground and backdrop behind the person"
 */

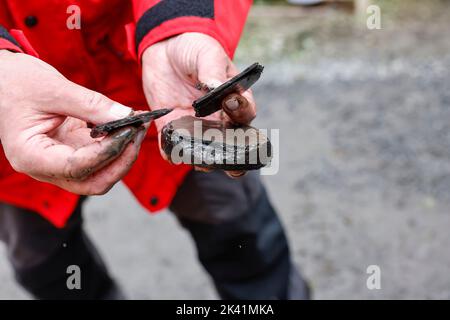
xmin=0 ymin=0 xmax=450 ymax=299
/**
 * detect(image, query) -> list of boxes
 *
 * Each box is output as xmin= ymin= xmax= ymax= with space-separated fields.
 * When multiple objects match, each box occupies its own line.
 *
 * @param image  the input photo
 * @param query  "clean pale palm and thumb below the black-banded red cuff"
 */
xmin=143 ymin=34 xmax=234 ymax=130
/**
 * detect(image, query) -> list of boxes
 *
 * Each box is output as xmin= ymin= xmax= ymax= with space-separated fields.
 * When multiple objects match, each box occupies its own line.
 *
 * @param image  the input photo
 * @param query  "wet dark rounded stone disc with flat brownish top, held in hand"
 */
xmin=161 ymin=116 xmax=272 ymax=171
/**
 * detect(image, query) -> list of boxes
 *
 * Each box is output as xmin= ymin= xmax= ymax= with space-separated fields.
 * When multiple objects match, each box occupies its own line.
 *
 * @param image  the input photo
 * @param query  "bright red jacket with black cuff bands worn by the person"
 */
xmin=0 ymin=0 xmax=252 ymax=227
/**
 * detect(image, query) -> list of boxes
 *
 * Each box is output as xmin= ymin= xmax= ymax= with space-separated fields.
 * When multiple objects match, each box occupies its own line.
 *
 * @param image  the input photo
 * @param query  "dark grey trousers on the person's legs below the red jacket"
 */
xmin=0 ymin=171 xmax=308 ymax=299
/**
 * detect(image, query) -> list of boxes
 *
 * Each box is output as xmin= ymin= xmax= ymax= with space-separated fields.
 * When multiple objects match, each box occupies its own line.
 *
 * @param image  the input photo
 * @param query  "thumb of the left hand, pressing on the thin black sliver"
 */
xmin=45 ymin=81 xmax=133 ymax=124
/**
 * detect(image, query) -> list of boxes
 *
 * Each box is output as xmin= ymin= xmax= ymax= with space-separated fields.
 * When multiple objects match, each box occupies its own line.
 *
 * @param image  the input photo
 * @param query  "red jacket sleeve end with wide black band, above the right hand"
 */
xmin=133 ymin=0 xmax=253 ymax=60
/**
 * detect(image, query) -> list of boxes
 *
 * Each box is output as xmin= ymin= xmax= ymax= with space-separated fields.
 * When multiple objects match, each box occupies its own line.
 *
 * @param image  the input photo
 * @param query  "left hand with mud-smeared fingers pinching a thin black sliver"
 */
xmin=0 ymin=50 xmax=146 ymax=195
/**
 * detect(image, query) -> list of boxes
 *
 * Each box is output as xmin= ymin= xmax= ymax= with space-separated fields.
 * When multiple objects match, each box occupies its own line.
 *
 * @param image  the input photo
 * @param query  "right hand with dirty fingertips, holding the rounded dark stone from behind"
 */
xmin=142 ymin=33 xmax=256 ymax=177
